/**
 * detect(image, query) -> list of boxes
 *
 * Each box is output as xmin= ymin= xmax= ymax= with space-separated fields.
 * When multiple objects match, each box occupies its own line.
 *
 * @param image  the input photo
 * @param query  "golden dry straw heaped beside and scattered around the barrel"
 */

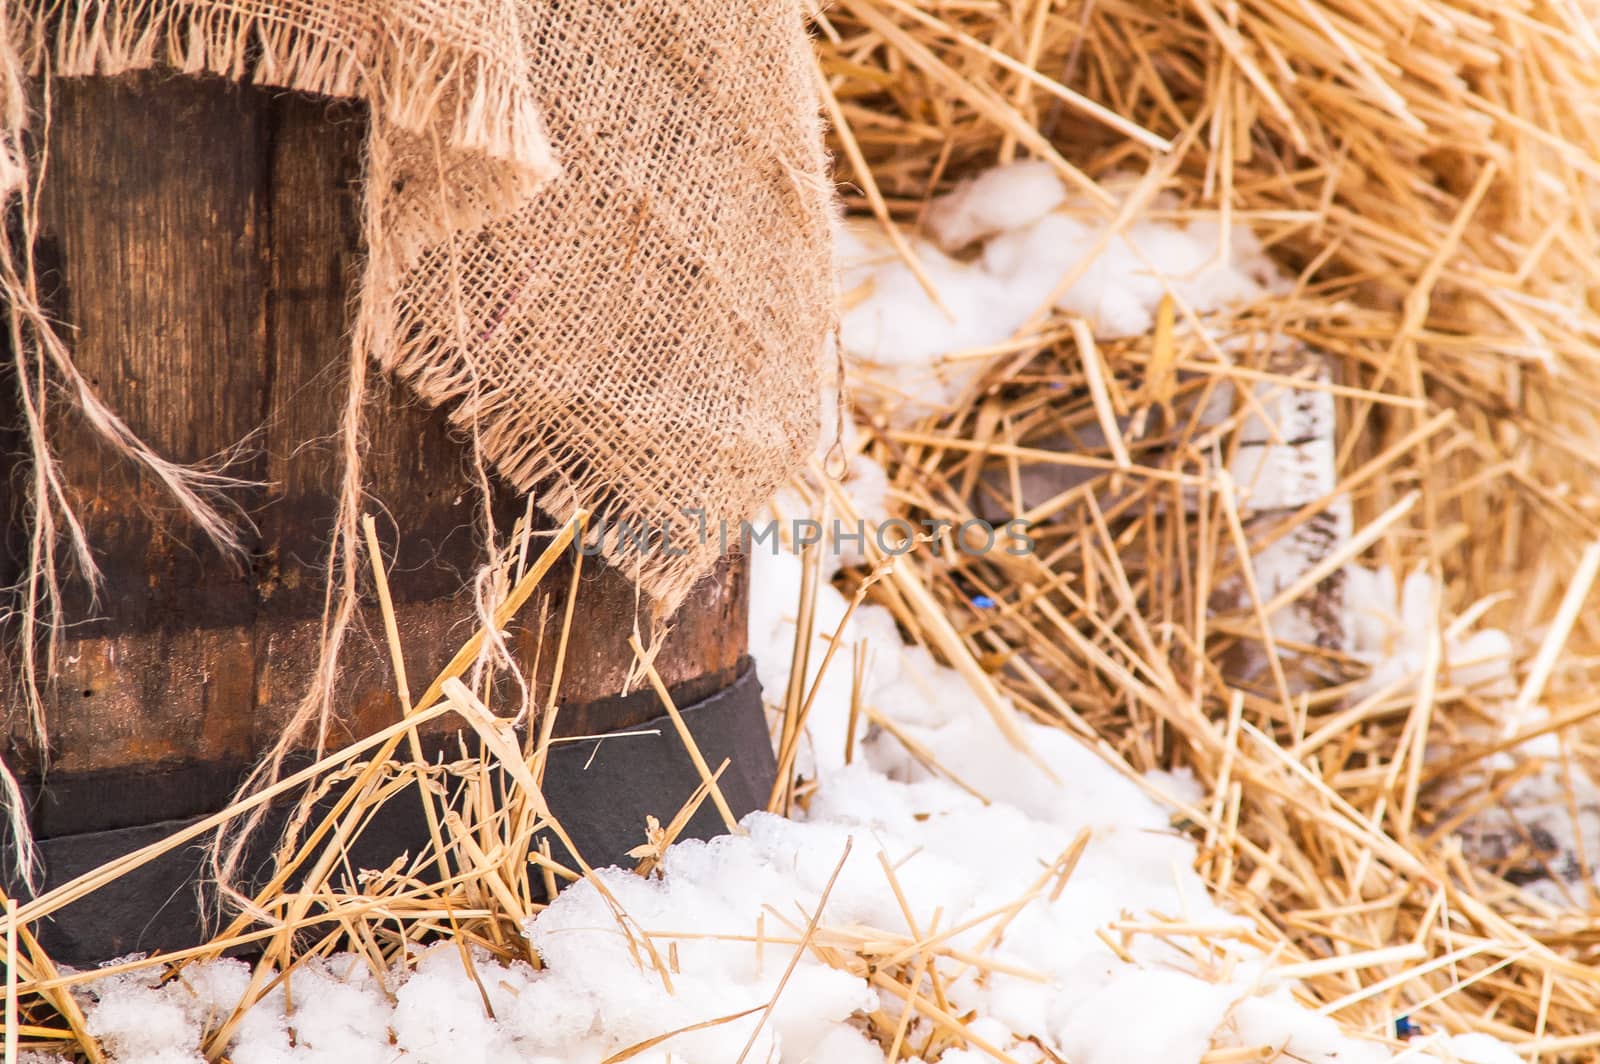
xmin=6 ymin=0 xmax=1600 ymax=1064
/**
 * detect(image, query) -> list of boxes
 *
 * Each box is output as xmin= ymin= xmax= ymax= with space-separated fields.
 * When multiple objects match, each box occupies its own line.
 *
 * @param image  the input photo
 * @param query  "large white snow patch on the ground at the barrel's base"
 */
xmin=72 ymin=531 xmax=1498 ymax=1064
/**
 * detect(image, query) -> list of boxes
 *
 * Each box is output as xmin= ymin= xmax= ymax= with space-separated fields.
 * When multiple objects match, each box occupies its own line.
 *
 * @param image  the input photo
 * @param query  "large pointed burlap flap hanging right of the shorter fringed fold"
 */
xmin=373 ymin=0 xmax=832 ymax=610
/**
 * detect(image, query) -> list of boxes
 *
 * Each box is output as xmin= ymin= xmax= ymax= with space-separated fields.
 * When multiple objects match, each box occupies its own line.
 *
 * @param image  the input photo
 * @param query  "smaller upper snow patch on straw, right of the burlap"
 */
xmin=837 ymin=162 xmax=1285 ymax=421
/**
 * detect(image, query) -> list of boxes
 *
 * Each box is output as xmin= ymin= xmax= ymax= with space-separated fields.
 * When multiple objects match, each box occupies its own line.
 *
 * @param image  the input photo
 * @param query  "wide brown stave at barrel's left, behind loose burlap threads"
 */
xmin=21 ymin=78 xmax=266 ymax=771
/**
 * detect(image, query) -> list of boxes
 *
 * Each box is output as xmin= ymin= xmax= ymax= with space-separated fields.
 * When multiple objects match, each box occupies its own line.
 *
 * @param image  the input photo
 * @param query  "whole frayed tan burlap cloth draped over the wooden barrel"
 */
xmin=0 ymin=0 xmax=832 ymax=611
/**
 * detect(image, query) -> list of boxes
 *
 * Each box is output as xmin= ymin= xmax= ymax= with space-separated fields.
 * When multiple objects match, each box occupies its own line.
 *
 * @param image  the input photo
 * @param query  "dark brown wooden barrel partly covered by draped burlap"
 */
xmin=0 ymin=74 xmax=771 ymax=960
